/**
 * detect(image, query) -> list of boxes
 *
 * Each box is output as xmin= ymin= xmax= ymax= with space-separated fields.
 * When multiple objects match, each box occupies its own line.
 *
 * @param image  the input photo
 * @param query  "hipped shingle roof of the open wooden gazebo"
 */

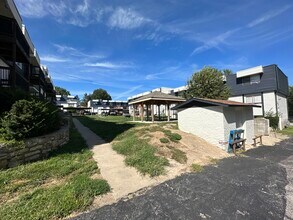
xmin=129 ymin=91 xmax=185 ymax=105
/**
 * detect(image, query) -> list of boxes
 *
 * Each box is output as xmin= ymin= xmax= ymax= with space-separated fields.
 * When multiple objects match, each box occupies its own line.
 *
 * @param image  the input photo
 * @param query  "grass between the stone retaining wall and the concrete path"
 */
xmin=0 ymin=128 xmax=110 ymax=220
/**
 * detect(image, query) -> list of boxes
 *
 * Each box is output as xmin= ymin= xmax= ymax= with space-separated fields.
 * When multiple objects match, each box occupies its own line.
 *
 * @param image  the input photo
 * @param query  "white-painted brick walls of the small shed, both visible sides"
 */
xmin=178 ymin=106 xmax=254 ymax=150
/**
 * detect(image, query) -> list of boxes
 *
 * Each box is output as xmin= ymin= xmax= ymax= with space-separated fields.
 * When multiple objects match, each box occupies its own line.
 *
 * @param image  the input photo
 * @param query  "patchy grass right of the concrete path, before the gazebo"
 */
xmin=77 ymin=116 xmax=181 ymax=176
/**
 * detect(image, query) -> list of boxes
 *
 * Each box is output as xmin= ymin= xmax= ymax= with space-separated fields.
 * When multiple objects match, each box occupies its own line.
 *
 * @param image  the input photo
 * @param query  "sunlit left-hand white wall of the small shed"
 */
xmin=178 ymin=106 xmax=227 ymax=149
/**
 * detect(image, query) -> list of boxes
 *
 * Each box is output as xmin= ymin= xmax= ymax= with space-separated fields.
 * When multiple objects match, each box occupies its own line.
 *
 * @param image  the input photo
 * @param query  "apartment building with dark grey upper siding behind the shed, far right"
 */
xmin=226 ymin=64 xmax=289 ymax=129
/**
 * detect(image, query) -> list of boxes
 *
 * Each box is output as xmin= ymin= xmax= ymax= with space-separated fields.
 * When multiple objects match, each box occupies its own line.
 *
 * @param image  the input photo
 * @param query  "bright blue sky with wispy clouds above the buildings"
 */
xmin=15 ymin=0 xmax=293 ymax=100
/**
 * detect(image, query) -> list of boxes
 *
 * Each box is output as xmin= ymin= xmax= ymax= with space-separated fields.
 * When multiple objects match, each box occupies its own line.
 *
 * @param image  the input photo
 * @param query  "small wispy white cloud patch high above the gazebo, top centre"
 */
xmin=108 ymin=8 xmax=150 ymax=29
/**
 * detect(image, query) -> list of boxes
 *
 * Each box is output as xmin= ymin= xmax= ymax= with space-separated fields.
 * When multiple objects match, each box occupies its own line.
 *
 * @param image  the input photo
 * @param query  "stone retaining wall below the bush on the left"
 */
xmin=0 ymin=125 xmax=69 ymax=169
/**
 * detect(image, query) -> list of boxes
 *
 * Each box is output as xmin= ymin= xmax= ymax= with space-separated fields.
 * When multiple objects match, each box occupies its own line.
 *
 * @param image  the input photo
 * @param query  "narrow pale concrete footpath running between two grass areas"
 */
xmin=73 ymin=118 xmax=158 ymax=201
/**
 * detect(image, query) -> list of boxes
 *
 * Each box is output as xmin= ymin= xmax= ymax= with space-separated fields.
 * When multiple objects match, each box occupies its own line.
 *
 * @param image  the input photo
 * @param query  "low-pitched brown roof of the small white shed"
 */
xmin=172 ymin=98 xmax=261 ymax=110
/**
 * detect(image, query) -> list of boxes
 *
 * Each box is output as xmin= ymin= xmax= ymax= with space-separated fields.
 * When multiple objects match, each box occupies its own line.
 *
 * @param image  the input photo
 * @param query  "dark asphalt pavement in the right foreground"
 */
xmin=75 ymin=139 xmax=293 ymax=220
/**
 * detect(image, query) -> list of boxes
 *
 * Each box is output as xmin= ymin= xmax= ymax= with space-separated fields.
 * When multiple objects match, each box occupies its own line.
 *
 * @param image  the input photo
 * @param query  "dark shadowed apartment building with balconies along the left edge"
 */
xmin=0 ymin=0 xmax=55 ymax=102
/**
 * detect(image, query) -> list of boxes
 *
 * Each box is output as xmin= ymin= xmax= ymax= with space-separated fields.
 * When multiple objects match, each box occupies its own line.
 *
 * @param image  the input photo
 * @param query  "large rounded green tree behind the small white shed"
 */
xmin=187 ymin=67 xmax=230 ymax=99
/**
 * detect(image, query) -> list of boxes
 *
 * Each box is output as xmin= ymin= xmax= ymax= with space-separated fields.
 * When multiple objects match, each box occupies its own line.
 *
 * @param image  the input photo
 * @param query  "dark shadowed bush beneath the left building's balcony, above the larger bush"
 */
xmin=0 ymin=88 xmax=30 ymax=115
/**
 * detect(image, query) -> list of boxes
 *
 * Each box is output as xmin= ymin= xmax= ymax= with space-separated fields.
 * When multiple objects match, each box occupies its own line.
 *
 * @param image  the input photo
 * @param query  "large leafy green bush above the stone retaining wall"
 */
xmin=0 ymin=99 xmax=60 ymax=140
